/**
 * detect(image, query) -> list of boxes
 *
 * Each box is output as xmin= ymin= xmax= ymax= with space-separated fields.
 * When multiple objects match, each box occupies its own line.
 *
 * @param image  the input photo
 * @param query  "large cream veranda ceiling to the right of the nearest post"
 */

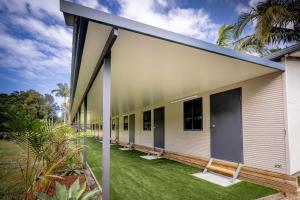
xmin=111 ymin=30 xmax=278 ymax=115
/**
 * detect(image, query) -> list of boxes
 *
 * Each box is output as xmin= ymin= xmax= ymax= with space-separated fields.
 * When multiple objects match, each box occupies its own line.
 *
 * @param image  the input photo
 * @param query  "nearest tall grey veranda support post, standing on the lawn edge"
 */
xmin=102 ymin=53 xmax=111 ymax=200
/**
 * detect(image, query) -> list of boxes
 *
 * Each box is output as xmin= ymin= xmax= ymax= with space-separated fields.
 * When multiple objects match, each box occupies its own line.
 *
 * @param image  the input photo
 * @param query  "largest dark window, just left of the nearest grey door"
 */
xmin=183 ymin=98 xmax=203 ymax=131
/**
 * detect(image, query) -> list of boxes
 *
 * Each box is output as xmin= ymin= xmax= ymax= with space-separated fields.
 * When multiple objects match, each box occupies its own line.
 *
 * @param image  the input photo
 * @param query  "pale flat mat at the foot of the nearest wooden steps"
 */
xmin=192 ymin=172 xmax=240 ymax=187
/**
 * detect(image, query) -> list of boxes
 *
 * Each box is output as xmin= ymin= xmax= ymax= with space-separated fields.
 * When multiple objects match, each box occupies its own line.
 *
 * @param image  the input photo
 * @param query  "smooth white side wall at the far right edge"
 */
xmin=284 ymin=58 xmax=300 ymax=174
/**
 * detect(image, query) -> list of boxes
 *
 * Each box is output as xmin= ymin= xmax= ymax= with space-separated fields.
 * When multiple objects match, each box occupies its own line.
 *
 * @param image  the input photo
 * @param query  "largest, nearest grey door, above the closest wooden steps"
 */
xmin=210 ymin=88 xmax=244 ymax=163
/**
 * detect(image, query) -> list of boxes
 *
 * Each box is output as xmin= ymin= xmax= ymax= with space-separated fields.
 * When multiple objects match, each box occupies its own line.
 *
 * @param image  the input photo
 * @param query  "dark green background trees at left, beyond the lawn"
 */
xmin=0 ymin=90 xmax=59 ymax=131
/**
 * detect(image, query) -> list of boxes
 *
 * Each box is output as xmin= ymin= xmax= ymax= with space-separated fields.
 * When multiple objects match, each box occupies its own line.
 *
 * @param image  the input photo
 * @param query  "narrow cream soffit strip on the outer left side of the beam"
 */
xmin=72 ymin=21 xmax=112 ymax=114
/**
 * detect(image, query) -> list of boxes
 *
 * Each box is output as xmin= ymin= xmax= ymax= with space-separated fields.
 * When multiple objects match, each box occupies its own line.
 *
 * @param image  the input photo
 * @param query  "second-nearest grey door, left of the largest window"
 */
xmin=154 ymin=107 xmax=165 ymax=149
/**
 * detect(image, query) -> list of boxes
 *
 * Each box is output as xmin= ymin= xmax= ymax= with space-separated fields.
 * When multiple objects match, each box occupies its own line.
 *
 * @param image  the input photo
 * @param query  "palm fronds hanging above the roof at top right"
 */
xmin=233 ymin=0 xmax=300 ymax=44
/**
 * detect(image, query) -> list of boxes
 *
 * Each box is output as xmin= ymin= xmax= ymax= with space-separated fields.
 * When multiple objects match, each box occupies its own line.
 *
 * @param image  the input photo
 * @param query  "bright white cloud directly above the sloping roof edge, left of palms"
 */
xmin=117 ymin=0 xmax=219 ymax=42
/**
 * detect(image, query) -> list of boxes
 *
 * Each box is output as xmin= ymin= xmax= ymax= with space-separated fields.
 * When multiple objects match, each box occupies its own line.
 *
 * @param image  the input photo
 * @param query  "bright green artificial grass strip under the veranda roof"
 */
xmin=87 ymin=138 xmax=277 ymax=200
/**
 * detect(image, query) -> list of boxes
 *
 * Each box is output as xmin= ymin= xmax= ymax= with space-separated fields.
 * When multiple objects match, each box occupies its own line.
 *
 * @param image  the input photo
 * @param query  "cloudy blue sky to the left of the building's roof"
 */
xmin=0 ymin=0 xmax=72 ymax=90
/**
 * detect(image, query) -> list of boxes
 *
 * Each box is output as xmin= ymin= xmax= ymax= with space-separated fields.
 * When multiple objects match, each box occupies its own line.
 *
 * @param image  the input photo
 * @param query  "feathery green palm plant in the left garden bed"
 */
xmin=8 ymin=112 xmax=81 ymax=198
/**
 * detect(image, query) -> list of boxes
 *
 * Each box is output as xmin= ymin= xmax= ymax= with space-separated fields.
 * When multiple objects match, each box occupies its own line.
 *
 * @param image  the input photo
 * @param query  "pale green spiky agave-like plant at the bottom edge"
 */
xmin=37 ymin=179 xmax=98 ymax=200
